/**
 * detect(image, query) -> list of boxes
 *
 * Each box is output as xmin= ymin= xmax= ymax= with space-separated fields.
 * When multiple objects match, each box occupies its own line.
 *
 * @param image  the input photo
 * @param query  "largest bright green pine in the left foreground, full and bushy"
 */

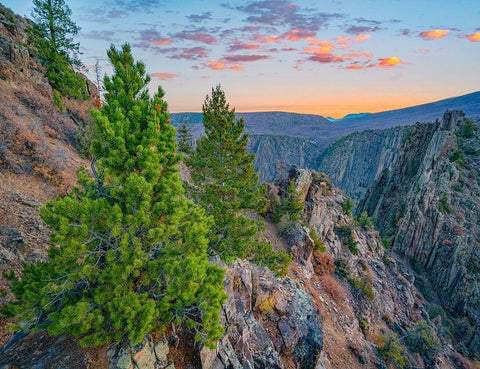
xmin=4 ymin=44 xmax=226 ymax=346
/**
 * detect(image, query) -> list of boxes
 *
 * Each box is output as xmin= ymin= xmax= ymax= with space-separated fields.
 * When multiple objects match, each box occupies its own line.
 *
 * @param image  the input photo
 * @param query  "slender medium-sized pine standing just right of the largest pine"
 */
xmin=187 ymin=86 xmax=290 ymax=274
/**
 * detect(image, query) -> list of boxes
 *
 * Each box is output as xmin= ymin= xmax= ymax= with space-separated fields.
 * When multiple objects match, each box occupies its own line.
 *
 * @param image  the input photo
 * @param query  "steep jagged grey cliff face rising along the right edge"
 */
xmin=358 ymin=111 xmax=480 ymax=358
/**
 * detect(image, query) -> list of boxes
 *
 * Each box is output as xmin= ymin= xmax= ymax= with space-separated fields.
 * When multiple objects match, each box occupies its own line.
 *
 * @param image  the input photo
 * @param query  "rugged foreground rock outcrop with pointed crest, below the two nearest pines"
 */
xmin=0 ymin=169 xmax=471 ymax=369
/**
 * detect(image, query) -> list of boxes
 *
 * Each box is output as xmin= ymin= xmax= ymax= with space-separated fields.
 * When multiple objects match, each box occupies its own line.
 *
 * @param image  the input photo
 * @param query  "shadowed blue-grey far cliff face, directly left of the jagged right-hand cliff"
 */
xmin=313 ymin=126 xmax=411 ymax=201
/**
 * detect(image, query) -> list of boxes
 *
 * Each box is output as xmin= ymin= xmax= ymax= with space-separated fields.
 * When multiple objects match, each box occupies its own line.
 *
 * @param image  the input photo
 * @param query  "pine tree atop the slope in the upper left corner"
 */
xmin=31 ymin=0 xmax=88 ymax=99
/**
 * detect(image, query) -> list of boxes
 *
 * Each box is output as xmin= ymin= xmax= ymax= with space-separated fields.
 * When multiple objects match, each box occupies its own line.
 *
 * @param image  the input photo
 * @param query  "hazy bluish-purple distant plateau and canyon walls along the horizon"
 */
xmin=171 ymin=91 xmax=480 ymax=182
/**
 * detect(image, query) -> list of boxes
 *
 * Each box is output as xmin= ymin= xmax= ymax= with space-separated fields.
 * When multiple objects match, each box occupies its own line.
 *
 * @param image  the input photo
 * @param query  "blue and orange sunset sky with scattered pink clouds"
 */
xmin=0 ymin=0 xmax=480 ymax=118
